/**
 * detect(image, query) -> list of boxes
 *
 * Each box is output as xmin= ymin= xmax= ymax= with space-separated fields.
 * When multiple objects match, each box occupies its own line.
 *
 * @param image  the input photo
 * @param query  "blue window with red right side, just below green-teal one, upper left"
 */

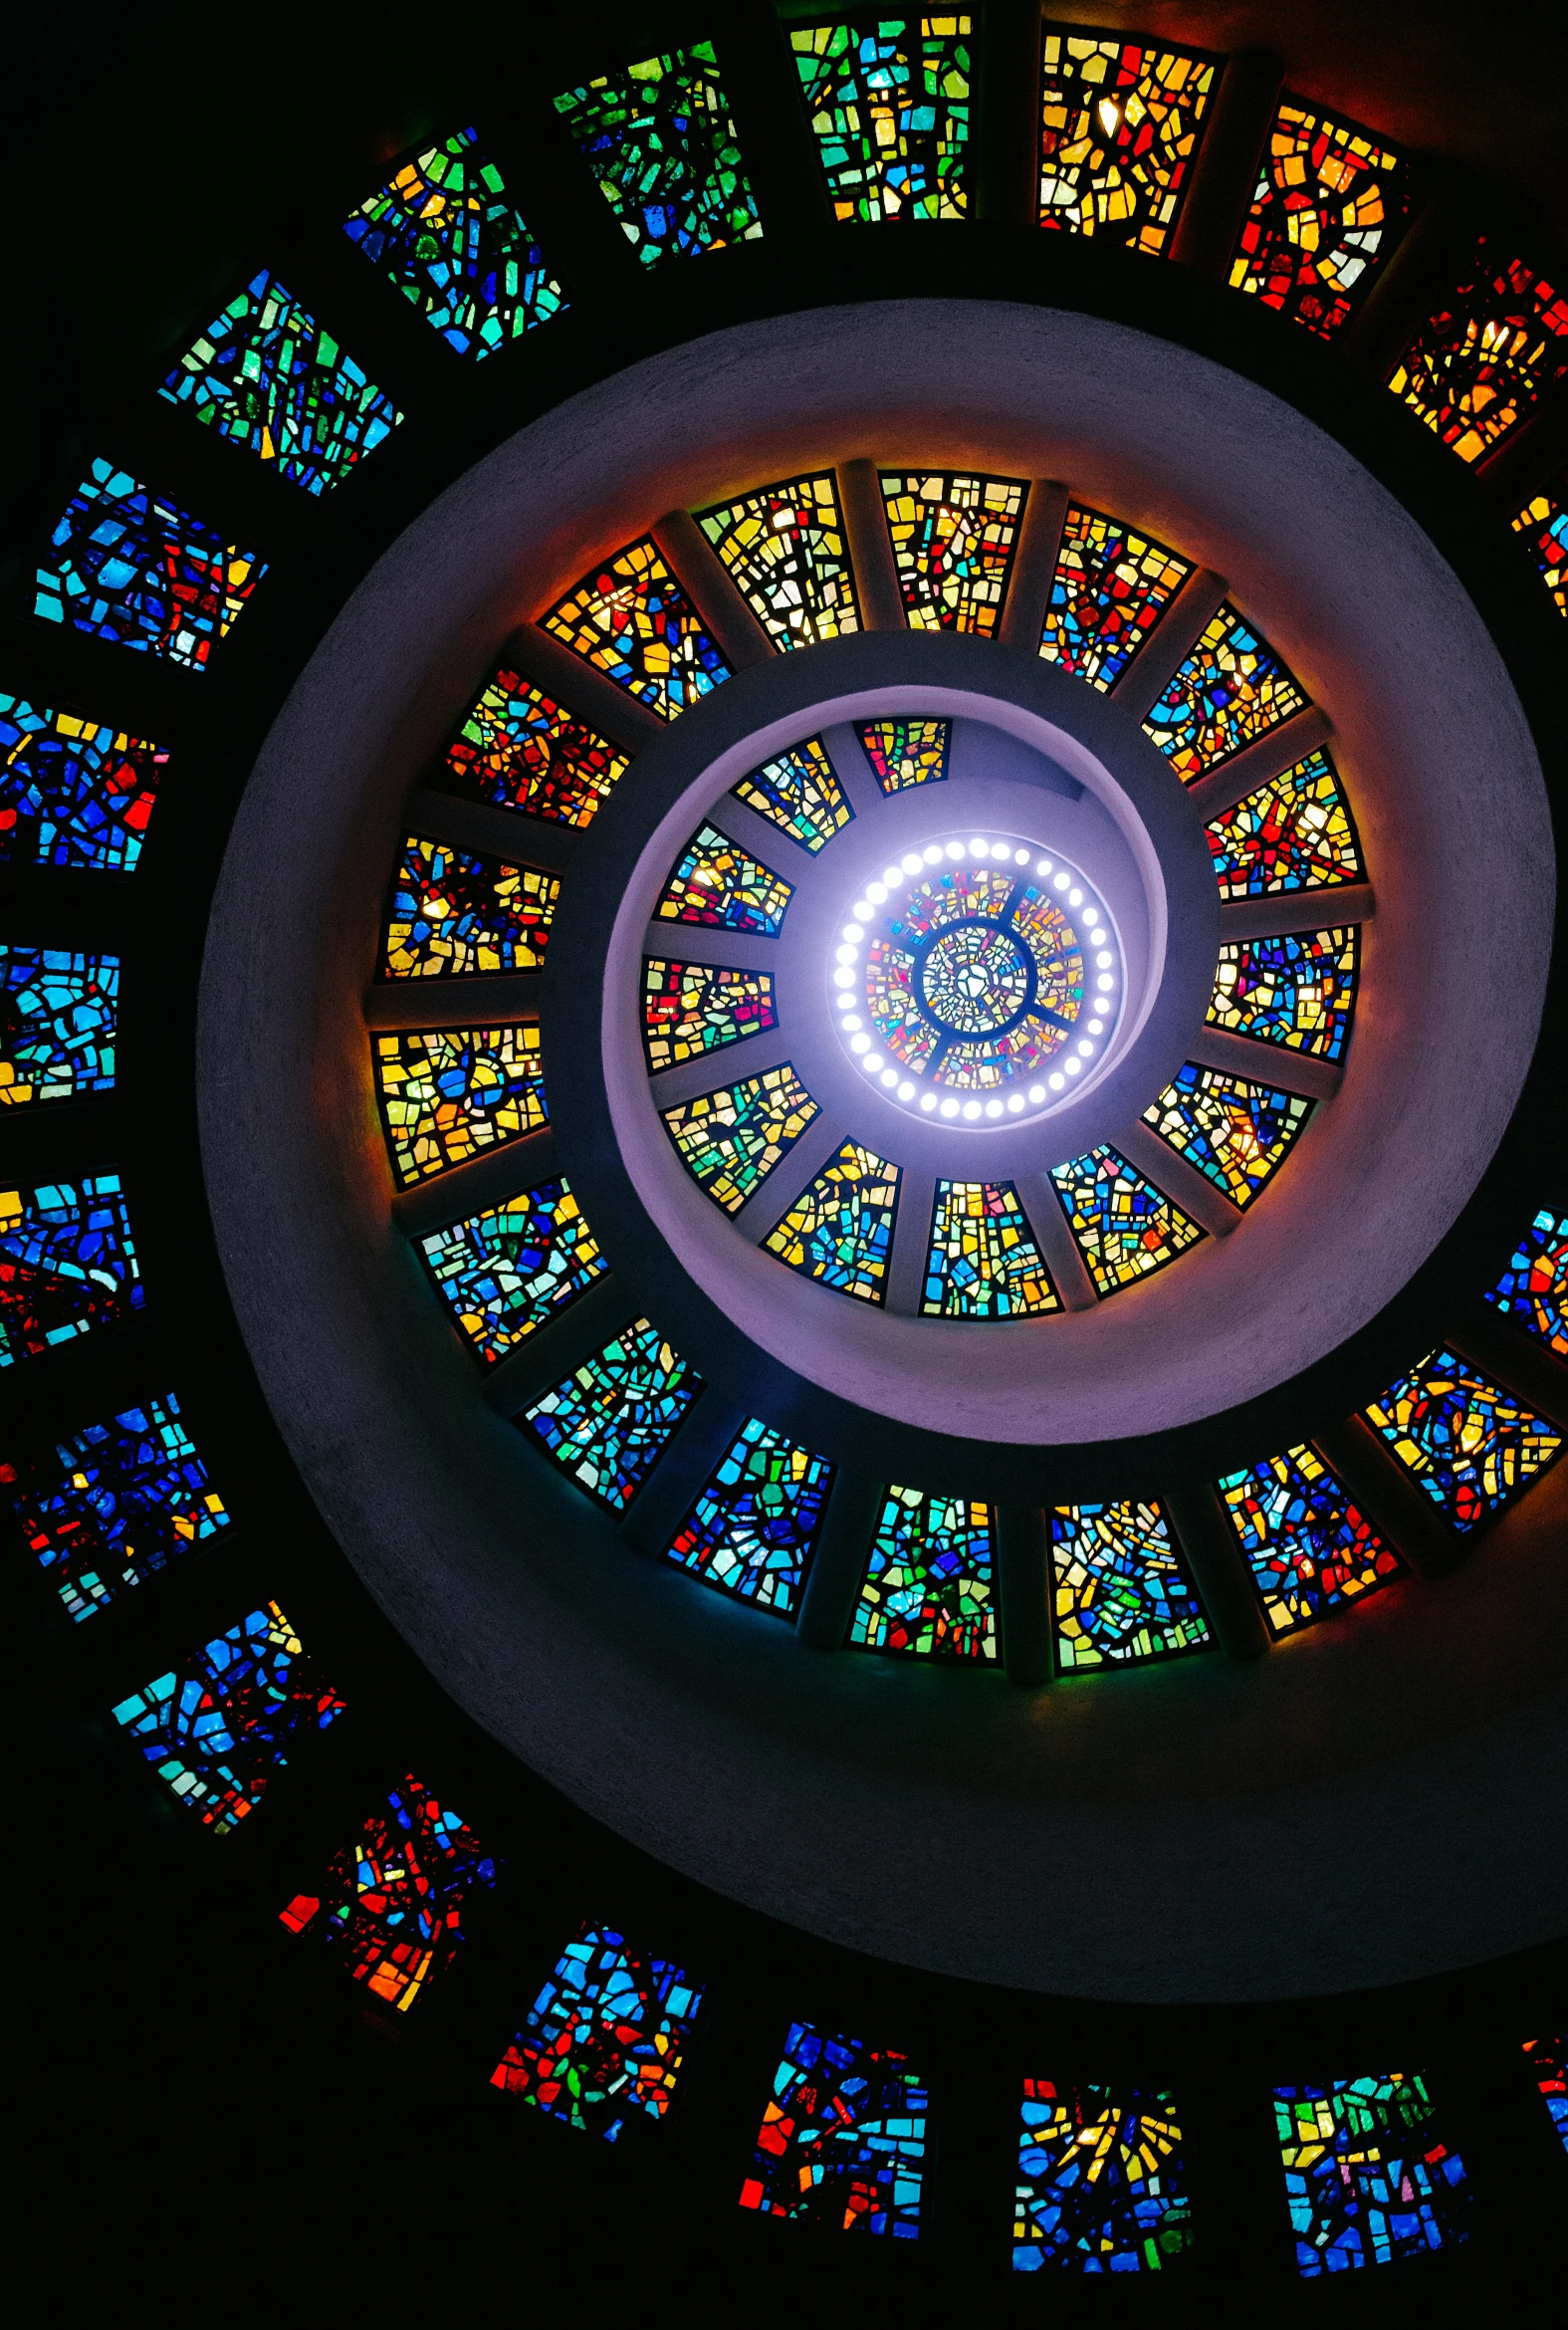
xmin=33 ymin=461 xmax=266 ymax=671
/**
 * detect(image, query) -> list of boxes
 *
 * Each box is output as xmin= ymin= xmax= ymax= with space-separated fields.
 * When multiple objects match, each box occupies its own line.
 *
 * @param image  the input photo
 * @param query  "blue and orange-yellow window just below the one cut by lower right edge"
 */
xmin=1365 ymin=1344 xmax=1563 ymax=1533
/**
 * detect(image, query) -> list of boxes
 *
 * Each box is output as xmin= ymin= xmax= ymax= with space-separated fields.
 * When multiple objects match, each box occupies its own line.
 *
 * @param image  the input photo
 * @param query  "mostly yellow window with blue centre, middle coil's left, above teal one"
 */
xmin=370 ymin=1023 xmax=550 ymax=1188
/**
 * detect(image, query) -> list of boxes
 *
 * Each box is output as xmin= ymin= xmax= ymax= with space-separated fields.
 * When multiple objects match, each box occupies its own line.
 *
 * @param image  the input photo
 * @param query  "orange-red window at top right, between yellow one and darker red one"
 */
xmin=1231 ymin=98 xmax=1410 ymax=341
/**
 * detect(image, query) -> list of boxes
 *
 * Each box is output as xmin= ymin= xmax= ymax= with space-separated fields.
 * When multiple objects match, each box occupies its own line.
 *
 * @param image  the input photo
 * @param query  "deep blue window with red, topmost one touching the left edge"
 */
xmin=0 ymin=694 xmax=167 ymax=874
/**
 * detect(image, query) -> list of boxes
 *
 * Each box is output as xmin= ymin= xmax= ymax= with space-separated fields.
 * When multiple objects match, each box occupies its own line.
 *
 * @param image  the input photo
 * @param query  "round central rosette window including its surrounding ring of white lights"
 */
xmin=831 ymin=836 xmax=1121 ymax=1123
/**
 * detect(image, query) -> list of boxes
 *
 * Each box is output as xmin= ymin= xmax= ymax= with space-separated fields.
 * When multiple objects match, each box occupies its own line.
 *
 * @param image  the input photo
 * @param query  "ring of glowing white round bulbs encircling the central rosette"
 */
xmin=829 ymin=834 xmax=1123 ymax=1130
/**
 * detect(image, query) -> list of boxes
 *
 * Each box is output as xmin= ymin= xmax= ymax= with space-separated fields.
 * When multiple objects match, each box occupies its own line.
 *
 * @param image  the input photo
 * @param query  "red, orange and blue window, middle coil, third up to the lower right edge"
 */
xmin=1219 ymin=1445 xmax=1401 ymax=1633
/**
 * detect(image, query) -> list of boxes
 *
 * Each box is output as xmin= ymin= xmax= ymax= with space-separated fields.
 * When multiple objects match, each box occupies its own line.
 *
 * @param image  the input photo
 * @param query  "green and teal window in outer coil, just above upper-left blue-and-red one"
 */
xmin=158 ymin=268 xmax=403 ymax=494
